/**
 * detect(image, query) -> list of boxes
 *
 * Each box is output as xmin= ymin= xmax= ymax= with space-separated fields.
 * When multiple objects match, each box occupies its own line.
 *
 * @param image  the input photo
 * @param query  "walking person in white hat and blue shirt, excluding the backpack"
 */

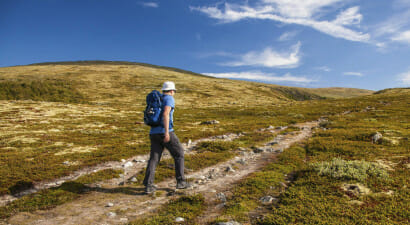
xmin=143 ymin=81 xmax=191 ymax=194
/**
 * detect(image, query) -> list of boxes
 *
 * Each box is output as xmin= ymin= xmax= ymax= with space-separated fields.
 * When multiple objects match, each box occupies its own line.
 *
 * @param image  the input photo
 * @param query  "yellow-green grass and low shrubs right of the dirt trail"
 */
xmin=258 ymin=93 xmax=410 ymax=224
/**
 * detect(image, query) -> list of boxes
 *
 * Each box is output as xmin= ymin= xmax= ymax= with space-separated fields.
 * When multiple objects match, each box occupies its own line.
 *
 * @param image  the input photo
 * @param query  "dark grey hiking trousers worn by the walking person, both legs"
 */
xmin=143 ymin=132 xmax=185 ymax=186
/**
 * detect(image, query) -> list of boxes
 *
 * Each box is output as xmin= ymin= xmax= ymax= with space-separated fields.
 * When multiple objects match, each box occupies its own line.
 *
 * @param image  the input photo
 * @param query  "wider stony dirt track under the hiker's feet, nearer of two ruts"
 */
xmin=3 ymin=121 xmax=319 ymax=225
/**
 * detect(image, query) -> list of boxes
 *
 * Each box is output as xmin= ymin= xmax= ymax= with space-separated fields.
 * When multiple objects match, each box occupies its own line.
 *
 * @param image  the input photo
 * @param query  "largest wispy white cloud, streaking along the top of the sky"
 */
xmin=190 ymin=0 xmax=370 ymax=42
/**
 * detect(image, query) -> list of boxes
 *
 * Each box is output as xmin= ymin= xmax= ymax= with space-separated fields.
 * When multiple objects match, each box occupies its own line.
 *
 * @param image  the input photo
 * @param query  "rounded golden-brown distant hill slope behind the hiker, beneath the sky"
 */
xmin=0 ymin=61 xmax=371 ymax=104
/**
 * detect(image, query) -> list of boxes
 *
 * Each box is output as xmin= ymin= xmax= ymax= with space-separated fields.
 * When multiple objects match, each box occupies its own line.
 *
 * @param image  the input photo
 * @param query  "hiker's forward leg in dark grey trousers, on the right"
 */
xmin=164 ymin=132 xmax=185 ymax=182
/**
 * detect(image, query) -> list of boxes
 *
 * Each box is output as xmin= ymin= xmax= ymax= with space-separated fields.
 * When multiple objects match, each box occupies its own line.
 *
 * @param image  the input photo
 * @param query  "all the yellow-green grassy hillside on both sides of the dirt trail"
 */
xmin=0 ymin=62 xmax=410 ymax=224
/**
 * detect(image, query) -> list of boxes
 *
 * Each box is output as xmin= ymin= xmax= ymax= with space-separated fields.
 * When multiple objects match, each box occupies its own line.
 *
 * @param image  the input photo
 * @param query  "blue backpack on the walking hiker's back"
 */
xmin=144 ymin=90 xmax=162 ymax=127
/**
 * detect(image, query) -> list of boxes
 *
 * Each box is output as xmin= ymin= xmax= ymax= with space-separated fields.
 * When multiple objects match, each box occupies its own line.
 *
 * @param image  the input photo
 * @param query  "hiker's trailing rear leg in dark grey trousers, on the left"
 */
xmin=143 ymin=134 xmax=164 ymax=186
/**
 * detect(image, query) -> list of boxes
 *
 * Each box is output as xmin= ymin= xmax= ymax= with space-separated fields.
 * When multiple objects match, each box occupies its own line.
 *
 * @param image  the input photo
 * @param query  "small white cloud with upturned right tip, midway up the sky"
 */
xmin=222 ymin=42 xmax=301 ymax=68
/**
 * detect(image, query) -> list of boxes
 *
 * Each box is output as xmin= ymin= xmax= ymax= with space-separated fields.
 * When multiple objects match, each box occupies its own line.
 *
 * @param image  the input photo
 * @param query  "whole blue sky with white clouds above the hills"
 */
xmin=0 ymin=0 xmax=410 ymax=90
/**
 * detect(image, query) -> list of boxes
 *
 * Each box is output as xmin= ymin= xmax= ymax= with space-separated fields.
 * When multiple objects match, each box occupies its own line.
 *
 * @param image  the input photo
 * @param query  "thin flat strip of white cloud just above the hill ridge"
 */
xmin=203 ymin=71 xmax=315 ymax=83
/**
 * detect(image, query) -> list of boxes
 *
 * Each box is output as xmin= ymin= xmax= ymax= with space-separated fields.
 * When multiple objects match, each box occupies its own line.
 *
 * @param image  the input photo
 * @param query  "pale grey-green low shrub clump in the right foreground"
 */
xmin=312 ymin=158 xmax=389 ymax=181
